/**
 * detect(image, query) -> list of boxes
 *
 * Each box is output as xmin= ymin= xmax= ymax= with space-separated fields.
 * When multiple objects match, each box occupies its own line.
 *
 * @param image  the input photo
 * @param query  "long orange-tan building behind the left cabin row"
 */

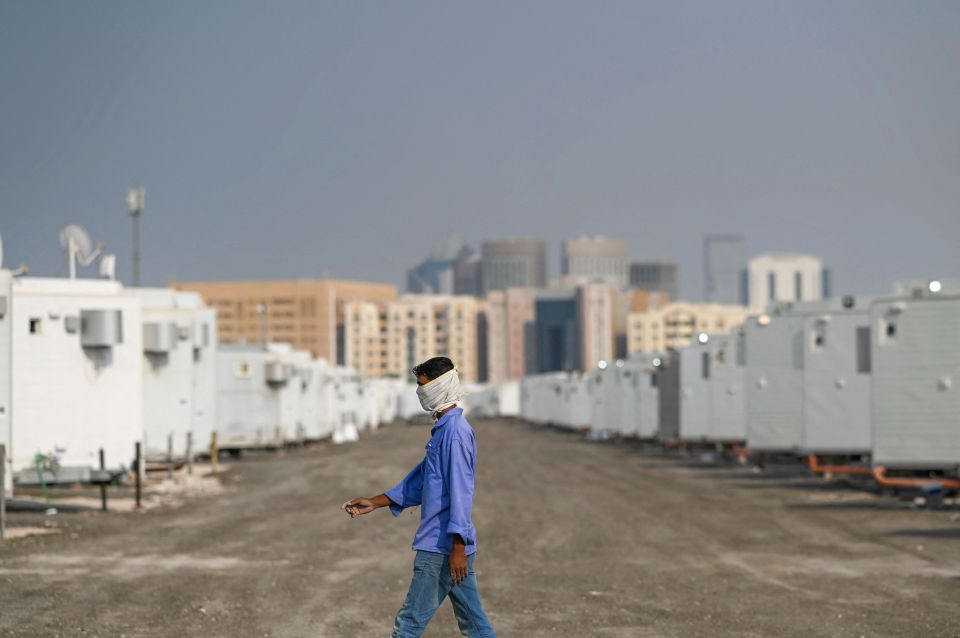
xmin=170 ymin=279 xmax=397 ymax=362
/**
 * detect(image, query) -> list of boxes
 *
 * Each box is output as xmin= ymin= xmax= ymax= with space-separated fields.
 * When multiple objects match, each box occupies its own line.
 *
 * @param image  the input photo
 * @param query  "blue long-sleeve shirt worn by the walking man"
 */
xmin=385 ymin=408 xmax=477 ymax=555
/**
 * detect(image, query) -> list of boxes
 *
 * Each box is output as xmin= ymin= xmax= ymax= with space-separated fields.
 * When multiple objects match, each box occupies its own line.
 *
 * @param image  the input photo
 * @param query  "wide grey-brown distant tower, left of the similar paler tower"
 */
xmin=480 ymin=239 xmax=547 ymax=293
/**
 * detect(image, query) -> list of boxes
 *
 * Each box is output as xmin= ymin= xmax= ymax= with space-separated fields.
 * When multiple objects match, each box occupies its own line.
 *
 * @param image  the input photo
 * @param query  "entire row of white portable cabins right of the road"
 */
xmin=521 ymin=280 xmax=960 ymax=471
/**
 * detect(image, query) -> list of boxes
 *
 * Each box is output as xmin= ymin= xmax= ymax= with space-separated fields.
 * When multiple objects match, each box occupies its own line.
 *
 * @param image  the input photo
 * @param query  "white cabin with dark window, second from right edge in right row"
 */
xmin=798 ymin=295 xmax=874 ymax=455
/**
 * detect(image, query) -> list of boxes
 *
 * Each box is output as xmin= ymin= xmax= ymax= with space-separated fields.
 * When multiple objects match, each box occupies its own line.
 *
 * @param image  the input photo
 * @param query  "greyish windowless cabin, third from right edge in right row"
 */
xmin=744 ymin=302 xmax=805 ymax=452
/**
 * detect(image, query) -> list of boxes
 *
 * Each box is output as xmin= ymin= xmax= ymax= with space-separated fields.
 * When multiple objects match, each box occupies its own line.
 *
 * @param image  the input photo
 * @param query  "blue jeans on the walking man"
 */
xmin=392 ymin=550 xmax=497 ymax=638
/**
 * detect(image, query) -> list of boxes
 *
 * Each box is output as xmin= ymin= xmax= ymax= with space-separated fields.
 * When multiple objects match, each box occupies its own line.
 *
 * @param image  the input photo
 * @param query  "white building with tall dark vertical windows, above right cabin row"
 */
xmin=747 ymin=252 xmax=829 ymax=313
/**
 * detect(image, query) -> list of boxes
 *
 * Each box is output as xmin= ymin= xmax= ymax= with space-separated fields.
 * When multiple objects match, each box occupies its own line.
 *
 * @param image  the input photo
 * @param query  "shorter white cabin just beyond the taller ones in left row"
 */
xmin=217 ymin=344 xmax=292 ymax=449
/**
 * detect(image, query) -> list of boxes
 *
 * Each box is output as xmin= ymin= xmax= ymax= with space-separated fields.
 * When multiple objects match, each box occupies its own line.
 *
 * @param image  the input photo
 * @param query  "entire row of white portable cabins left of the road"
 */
xmin=0 ymin=270 xmax=419 ymax=492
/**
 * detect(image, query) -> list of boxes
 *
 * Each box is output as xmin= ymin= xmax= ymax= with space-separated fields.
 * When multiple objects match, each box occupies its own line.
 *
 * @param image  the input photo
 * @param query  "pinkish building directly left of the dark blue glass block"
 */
xmin=486 ymin=288 xmax=535 ymax=382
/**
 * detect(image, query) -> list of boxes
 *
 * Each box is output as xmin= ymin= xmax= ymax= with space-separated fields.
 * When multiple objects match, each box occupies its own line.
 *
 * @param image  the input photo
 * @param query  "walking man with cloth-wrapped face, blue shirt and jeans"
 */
xmin=342 ymin=357 xmax=496 ymax=638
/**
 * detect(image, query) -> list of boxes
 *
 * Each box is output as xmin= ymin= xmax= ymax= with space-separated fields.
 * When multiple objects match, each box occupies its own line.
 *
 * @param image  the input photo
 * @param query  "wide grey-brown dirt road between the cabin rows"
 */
xmin=0 ymin=421 xmax=960 ymax=638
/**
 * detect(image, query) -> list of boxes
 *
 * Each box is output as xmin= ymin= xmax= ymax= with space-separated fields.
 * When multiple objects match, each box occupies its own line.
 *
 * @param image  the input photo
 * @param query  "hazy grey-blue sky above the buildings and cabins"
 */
xmin=0 ymin=0 xmax=960 ymax=298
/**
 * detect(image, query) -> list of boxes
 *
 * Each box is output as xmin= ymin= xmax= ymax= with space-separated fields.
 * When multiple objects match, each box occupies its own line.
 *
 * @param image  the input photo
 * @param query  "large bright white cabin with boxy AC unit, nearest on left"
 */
xmin=3 ymin=277 xmax=143 ymax=481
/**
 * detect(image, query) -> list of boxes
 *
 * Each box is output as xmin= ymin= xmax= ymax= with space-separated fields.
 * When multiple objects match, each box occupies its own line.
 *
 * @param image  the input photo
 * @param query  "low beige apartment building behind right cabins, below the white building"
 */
xmin=627 ymin=301 xmax=748 ymax=353
